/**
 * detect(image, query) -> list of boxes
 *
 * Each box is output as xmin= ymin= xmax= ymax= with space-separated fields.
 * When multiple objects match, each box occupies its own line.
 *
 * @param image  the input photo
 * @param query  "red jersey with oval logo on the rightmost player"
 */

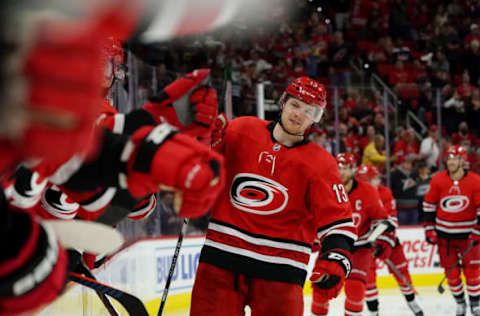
xmin=423 ymin=170 xmax=480 ymax=239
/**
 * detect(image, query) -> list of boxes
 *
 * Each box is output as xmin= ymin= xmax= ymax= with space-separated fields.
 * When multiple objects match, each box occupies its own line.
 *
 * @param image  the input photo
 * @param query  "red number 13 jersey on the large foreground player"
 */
xmin=200 ymin=117 xmax=356 ymax=285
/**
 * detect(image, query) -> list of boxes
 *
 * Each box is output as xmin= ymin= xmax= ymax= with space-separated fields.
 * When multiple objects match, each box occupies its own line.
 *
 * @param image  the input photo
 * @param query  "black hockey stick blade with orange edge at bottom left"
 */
xmin=69 ymin=272 xmax=148 ymax=316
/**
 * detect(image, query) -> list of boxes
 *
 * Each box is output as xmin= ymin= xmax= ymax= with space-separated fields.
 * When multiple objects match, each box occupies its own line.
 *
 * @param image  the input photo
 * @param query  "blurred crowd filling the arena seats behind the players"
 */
xmin=125 ymin=0 xmax=480 ymax=227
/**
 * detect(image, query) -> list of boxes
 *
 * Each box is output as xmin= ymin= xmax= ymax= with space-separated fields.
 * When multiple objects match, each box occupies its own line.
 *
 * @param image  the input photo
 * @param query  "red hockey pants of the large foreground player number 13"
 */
xmin=190 ymin=262 xmax=303 ymax=316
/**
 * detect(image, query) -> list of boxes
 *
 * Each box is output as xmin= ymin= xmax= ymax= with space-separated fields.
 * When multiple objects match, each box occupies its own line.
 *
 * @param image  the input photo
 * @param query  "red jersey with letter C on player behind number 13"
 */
xmin=348 ymin=179 xmax=388 ymax=246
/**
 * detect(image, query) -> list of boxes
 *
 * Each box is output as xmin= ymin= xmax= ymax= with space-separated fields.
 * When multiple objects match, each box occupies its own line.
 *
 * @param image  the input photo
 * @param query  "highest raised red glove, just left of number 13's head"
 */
xmin=143 ymin=69 xmax=218 ymax=136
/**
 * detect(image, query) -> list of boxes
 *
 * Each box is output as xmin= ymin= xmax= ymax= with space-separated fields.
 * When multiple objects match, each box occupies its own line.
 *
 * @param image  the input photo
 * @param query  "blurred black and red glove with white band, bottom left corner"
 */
xmin=0 ymin=209 xmax=68 ymax=315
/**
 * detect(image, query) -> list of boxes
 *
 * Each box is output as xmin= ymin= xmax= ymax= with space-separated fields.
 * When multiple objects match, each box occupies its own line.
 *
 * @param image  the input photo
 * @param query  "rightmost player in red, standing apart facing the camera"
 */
xmin=423 ymin=145 xmax=480 ymax=316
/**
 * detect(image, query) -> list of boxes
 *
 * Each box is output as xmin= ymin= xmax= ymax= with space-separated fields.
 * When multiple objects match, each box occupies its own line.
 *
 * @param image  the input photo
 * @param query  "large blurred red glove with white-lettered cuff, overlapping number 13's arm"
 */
xmin=126 ymin=124 xmax=225 ymax=218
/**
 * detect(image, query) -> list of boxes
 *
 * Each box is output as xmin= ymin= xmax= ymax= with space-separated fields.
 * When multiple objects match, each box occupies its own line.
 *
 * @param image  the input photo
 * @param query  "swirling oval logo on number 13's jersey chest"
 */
xmin=230 ymin=173 xmax=288 ymax=215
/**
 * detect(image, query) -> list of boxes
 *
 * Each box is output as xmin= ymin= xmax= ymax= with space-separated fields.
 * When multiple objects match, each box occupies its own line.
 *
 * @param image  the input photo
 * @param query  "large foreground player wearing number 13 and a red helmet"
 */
xmin=190 ymin=77 xmax=356 ymax=316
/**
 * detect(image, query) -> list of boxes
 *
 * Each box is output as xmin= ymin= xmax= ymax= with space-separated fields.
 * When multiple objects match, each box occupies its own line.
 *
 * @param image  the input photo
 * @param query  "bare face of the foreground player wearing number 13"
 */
xmin=281 ymin=98 xmax=313 ymax=135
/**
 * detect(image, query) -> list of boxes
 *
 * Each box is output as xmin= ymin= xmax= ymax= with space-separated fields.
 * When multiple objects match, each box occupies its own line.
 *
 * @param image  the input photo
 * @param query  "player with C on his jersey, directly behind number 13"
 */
xmin=312 ymin=153 xmax=394 ymax=316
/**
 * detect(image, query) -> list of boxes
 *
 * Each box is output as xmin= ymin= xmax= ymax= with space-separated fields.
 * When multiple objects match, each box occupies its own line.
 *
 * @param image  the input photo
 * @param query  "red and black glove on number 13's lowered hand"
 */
xmin=310 ymin=249 xmax=352 ymax=301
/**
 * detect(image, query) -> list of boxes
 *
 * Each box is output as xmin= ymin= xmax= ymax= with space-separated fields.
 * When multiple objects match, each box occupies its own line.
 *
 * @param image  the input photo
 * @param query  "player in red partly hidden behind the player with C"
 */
xmin=355 ymin=165 xmax=423 ymax=316
